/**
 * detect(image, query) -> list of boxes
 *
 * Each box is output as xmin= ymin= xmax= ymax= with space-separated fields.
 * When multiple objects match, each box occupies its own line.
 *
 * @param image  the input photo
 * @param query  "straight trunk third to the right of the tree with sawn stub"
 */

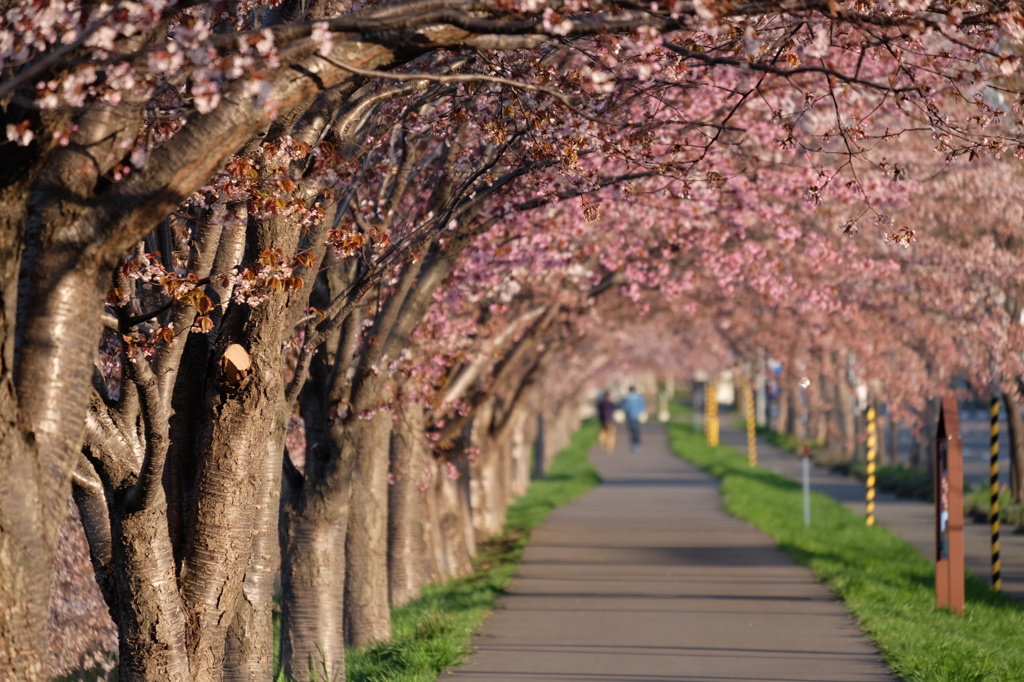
xmin=388 ymin=404 xmax=426 ymax=608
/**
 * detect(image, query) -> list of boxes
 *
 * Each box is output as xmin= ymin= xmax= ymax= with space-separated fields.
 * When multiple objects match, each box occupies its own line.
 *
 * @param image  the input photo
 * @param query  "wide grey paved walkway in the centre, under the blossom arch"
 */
xmin=444 ymin=425 xmax=893 ymax=682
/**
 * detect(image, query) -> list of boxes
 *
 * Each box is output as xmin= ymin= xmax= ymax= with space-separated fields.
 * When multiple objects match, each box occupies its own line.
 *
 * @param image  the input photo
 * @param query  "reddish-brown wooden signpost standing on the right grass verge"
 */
xmin=935 ymin=397 xmax=964 ymax=614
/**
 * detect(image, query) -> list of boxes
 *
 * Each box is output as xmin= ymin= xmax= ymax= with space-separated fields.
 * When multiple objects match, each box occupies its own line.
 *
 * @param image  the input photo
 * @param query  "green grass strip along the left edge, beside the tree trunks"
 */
xmin=346 ymin=421 xmax=601 ymax=682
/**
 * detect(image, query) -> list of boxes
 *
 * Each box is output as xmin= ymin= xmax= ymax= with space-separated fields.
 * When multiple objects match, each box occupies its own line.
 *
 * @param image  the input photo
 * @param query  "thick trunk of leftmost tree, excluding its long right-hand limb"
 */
xmin=0 ymin=98 xmax=148 ymax=680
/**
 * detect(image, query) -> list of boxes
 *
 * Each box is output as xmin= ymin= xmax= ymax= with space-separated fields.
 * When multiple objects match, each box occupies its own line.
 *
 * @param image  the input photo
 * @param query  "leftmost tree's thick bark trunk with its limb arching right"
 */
xmin=0 ymin=18 xmax=487 ymax=680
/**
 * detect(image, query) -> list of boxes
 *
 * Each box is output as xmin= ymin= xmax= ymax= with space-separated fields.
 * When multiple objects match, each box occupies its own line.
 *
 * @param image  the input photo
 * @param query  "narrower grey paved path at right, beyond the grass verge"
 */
xmin=721 ymin=419 xmax=1024 ymax=603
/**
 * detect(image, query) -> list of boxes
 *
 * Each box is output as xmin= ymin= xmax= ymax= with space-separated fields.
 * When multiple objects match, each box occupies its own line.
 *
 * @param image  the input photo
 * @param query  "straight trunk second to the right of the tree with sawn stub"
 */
xmin=345 ymin=411 xmax=391 ymax=646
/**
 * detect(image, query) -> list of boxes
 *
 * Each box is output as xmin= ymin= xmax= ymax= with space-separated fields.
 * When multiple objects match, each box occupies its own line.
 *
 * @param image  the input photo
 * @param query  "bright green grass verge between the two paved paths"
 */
xmin=669 ymin=423 xmax=1024 ymax=682
